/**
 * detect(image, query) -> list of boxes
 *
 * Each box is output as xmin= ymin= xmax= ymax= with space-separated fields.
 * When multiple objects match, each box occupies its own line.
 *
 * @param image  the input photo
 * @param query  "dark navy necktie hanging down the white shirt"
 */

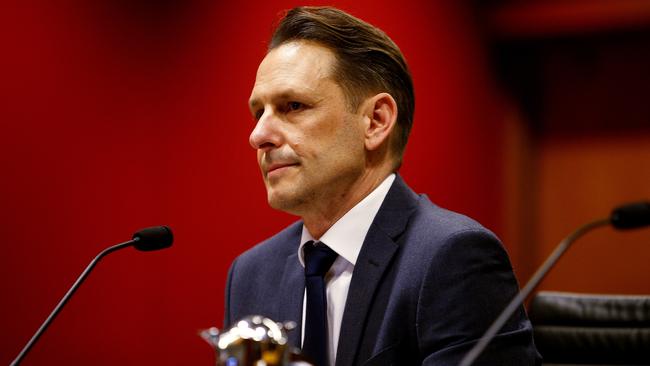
xmin=302 ymin=241 xmax=338 ymax=366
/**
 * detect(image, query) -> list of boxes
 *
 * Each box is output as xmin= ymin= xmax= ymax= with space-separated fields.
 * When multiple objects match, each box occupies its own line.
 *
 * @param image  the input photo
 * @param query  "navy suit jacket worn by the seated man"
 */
xmin=224 ymin=176 xmax=539 ymax=366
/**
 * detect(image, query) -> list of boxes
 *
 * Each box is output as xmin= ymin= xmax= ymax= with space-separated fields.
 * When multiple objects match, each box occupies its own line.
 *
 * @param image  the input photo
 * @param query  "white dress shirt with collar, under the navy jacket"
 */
xmin=298 ymin=174 xmax=395 ymax=366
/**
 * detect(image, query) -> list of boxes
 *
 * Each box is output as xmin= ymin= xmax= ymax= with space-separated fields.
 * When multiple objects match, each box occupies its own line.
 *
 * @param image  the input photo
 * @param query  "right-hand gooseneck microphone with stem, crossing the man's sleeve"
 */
xmin=460 ymin=202 xmax=650 ymax=366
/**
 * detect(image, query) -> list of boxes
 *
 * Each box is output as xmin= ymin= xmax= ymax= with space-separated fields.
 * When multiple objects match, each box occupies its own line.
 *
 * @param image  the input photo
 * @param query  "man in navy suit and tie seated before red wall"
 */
xmin=225 ymin=7 xmax=538 ymax=366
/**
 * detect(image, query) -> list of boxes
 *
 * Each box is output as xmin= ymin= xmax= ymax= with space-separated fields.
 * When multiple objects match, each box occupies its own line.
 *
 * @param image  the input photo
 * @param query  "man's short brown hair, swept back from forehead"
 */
xmin=269 ymin=6 xmax=415 ymax=166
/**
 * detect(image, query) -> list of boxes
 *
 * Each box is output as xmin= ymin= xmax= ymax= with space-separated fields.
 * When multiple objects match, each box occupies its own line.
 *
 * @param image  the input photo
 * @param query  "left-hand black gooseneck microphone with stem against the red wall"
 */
xmin=11 ymin=226 xmax=174 ymax=366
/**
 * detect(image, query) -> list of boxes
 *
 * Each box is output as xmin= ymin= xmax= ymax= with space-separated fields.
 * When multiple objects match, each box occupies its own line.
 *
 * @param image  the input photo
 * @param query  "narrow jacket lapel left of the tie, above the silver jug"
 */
xmin=276 ymin=253 xmax=305 ymax=348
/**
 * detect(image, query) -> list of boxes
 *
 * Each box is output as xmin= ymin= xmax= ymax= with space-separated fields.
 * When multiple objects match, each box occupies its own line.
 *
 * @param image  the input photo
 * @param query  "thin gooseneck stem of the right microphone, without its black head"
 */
xmin=460 ymin=217 xmax=612 ymax=366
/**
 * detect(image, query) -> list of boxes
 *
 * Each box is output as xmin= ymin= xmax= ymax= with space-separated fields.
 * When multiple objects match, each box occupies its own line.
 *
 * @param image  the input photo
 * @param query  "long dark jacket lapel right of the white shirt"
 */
xmin=336 ymin=175 xmax=418 ymax=366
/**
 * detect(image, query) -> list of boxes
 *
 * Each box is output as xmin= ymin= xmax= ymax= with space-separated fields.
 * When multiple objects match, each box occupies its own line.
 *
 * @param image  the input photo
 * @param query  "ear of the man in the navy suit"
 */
xmin=364 ymin=93 xmax=397 ymax=151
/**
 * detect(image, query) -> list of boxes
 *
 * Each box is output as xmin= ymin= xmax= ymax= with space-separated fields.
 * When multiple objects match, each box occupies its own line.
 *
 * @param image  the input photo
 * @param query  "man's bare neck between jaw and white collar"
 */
xmin=301 ymin=171 xmax=392 ymax=240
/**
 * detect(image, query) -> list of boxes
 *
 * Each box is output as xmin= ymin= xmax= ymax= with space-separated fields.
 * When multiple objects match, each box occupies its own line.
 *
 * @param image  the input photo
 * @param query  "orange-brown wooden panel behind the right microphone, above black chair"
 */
xmin=536 ymin=135 xmax=650 ymax=293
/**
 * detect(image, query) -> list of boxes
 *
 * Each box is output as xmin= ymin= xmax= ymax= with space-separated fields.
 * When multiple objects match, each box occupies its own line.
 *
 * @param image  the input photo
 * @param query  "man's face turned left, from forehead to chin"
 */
xmin=250 ymin=41 xmax=365 ymax=216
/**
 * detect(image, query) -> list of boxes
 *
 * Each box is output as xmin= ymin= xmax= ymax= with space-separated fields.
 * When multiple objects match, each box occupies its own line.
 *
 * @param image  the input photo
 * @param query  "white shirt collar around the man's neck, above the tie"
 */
xmin=298 ymin=173 xmax=395 ymax=267
